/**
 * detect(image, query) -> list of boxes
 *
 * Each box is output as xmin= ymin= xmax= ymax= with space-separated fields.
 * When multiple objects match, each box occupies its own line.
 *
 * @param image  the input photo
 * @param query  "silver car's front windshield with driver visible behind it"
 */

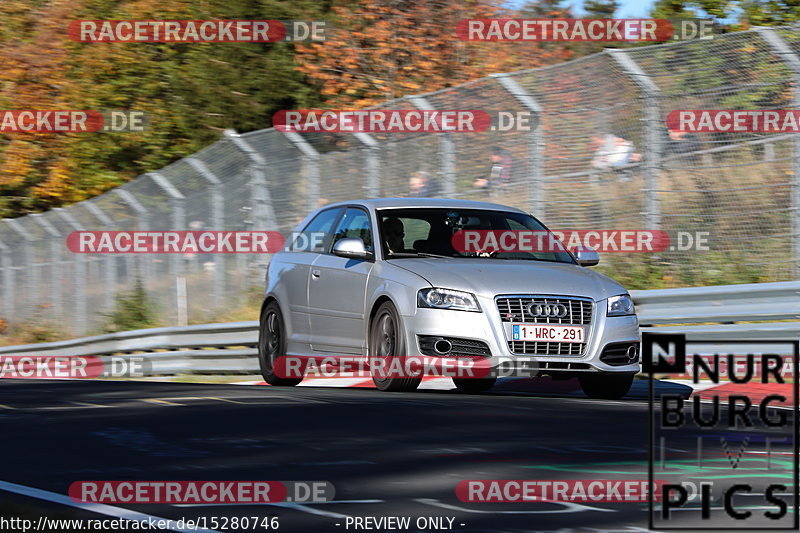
xmin=378 ymin=208 xmax=575 ymax=264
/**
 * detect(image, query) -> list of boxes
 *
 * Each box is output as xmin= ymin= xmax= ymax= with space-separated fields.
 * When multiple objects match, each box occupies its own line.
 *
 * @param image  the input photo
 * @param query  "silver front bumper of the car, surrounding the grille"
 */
xmin=403 ymin=296 xmax=640 ymax=373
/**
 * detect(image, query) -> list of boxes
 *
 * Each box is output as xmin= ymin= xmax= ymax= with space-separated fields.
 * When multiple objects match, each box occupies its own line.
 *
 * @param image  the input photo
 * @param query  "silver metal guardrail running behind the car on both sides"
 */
xmin=0 ymin=282 xmax=800 ymax=375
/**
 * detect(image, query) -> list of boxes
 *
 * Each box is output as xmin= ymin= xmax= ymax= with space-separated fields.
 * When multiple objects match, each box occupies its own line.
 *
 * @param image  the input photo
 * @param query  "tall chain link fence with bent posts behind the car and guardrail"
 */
xmin=0 ymin=27 xmax=800 ymax=334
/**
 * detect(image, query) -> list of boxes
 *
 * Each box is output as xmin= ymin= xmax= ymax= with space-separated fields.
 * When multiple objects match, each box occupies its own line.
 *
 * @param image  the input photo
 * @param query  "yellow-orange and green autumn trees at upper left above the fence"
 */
xmin=0 ymin=0 xmax=326 ymax=217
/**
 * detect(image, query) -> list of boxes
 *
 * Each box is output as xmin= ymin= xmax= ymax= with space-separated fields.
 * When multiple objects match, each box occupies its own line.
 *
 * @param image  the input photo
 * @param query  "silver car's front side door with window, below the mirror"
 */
xmin=308 ymin=207 xmax=375 ymax=354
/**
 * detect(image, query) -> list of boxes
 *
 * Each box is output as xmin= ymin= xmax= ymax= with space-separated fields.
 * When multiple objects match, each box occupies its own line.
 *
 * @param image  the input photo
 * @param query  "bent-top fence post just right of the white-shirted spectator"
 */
xmin=606 ymin=49 xmax=664 ymax=230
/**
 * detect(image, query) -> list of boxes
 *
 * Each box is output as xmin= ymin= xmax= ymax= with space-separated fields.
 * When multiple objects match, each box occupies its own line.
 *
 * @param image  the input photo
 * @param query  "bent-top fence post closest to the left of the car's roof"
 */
xmin=224 ymin=129 xmax=278 ymax=290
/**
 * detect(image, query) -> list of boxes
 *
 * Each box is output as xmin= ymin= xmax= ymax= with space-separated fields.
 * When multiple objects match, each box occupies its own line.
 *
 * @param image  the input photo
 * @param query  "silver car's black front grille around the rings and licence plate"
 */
xmin=496 ymin=296 xmax=594 ymax=357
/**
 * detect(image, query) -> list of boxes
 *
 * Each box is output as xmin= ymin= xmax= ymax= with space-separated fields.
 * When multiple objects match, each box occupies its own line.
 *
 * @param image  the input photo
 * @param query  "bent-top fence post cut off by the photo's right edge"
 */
xmin=756 ymin=27 xmax=800 ymax=279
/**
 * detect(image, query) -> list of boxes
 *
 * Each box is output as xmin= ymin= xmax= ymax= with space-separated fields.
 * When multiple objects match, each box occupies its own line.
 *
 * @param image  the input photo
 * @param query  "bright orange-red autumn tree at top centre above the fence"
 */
xmin=298 ymin=0 xmax=568 ymax=107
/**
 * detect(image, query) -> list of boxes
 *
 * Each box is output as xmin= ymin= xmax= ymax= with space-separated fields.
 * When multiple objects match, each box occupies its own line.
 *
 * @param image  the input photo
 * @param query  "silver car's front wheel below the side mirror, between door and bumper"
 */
xmin=368 ymin=302 xmax=422 ymax=392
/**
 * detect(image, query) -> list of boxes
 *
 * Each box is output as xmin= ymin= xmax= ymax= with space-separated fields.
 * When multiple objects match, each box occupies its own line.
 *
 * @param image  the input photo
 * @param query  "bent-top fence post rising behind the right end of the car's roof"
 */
xmin=492 ymin=74 xmax=546 ymax=216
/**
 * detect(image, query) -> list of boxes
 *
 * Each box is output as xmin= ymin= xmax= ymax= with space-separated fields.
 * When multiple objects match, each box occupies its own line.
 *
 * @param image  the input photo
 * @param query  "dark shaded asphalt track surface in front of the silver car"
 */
xmin=0 ymin=380 xmax=791 ymax=533
